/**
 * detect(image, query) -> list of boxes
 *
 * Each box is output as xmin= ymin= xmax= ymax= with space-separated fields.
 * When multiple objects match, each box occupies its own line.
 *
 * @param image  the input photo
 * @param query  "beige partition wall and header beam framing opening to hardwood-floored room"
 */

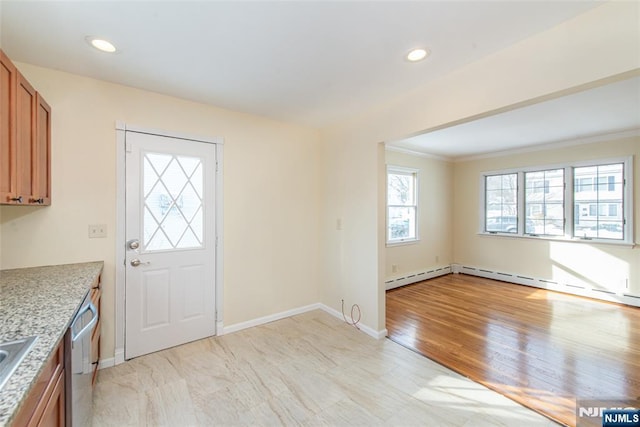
xmin=322 ymin=2 xmax=640 ymax=331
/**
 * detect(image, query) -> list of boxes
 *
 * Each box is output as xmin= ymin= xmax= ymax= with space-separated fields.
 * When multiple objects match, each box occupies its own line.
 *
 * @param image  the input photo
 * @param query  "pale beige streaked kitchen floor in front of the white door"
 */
xmin=94 ymin=310 xmax=555 ymax=427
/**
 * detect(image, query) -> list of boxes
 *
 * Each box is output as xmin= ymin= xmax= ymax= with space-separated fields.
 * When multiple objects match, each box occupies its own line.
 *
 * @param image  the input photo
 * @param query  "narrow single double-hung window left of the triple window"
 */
xmin=387 ymin=166 xmax=418 ymax=244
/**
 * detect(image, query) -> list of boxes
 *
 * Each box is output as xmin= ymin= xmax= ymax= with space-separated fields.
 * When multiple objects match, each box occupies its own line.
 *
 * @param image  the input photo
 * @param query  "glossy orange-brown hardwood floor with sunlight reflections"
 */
xmin=386 ymin=274 xmax=640 ymax=426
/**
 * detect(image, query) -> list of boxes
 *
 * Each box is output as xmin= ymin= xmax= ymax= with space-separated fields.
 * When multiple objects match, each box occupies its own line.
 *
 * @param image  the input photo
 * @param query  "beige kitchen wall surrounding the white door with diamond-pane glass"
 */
xmin=0 ymin=63 xmax=320 ymax=358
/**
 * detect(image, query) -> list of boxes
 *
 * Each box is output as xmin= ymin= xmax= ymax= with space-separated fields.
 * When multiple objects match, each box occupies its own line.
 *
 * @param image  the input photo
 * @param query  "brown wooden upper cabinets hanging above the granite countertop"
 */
xmin=0 ymin=50 xmax=51 ymax=205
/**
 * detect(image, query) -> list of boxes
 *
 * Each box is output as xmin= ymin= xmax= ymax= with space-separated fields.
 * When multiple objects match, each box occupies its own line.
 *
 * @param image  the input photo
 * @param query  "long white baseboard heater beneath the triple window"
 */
xmin=451 ymin=264 xmax=640 ymax=307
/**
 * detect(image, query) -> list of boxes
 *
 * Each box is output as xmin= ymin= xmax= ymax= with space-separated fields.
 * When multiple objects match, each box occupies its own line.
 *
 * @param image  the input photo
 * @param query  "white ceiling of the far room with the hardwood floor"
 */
xmin=389 ymin=77 xmax=640 ymax=158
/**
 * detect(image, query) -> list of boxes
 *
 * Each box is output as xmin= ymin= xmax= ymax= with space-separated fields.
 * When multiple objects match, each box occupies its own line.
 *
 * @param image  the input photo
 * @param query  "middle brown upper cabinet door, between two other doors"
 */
xmin=16 ymin=73 xmax=37 ymax=203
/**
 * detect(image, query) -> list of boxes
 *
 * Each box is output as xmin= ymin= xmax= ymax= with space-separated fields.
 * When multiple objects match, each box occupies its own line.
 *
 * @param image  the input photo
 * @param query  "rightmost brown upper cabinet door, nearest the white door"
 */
xmin=35 ymin=93 xmax=51 ymax=205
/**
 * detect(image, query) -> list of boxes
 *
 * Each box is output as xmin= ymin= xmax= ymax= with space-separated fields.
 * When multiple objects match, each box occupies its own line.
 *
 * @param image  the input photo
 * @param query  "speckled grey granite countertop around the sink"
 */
xmin=0 ymin=262 xmax=103 ymax=426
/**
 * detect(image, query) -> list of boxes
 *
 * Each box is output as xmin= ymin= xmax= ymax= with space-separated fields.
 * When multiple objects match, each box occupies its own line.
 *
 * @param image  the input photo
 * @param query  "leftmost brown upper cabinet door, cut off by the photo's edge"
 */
xmin=0 ymin=50 xmax=17 ymax=203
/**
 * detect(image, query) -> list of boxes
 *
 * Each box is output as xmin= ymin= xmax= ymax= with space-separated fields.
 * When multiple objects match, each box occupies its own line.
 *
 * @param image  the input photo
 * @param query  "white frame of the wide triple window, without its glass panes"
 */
xmin=478 ymin=156 xmax=635 ymax=247
